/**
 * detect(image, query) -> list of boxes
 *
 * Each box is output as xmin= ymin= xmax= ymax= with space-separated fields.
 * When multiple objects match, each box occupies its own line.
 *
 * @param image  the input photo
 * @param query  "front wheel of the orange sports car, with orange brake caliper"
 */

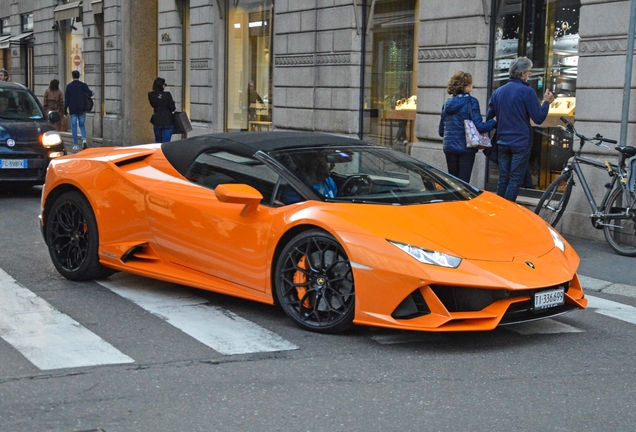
xmin=275 ymin=229 xmax=355 ymax=333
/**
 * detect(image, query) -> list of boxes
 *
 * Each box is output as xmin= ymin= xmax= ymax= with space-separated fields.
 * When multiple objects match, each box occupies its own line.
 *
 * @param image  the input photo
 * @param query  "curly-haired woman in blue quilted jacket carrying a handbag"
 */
xmin=439 ymin=71 xmax=497 ymax=183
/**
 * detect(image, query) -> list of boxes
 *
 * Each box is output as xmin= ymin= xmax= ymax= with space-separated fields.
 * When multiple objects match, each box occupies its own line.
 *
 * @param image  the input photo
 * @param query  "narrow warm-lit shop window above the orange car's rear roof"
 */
xmin=226 ymin=0 xmax=274 ymax=131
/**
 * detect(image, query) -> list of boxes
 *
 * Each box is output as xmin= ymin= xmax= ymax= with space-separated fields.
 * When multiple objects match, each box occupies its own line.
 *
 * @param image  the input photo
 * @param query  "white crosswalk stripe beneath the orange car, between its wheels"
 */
xmin=97 ymin=274 xmax=298 ymax=355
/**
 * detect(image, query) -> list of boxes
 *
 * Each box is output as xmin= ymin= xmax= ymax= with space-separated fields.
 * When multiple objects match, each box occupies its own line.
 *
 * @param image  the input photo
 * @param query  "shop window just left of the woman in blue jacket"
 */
xmin=363 ymin=0 xmax=418 ymax=151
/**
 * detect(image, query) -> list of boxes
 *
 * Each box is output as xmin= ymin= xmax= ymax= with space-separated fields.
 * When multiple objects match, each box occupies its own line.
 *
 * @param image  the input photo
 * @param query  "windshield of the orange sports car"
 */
xmin=270 ymin=146 xmax=481 ymax=205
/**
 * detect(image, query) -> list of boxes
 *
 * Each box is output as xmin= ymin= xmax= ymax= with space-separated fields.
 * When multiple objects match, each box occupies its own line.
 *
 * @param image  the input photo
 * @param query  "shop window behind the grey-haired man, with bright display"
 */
xmin=486 ymin=0 xmax=581 ymax=195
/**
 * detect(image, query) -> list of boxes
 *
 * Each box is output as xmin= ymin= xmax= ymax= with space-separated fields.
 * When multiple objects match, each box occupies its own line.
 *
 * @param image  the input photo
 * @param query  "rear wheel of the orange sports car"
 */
xmin=44 ymin=191 xmax=114 ymax=281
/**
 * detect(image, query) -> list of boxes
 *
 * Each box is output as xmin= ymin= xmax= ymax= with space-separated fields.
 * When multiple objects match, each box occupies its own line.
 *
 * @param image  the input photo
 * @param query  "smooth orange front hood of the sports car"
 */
xmin=312 ymin=192 xmax=554 ymax=262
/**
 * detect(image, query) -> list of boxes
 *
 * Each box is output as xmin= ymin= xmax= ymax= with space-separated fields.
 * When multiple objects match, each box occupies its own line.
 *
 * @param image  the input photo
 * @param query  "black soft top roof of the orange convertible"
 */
xmin=161 ymin=131 xmax=369 ymax=176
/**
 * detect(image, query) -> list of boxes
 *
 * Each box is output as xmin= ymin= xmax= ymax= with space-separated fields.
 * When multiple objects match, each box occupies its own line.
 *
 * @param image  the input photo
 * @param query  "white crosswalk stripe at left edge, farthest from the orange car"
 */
xmin=0 ymin=269 xmax=134 ymax=370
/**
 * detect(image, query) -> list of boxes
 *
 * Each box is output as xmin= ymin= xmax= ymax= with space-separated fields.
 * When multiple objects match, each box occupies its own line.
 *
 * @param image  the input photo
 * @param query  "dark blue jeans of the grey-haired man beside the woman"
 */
xmin=497 ymin=144 xmax=532 ymax=201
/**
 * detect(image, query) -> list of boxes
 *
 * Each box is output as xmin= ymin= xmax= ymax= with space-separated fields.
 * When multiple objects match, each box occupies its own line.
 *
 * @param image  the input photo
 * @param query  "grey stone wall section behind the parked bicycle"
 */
xmin=558 ymin=0 xmax=636 ymax=239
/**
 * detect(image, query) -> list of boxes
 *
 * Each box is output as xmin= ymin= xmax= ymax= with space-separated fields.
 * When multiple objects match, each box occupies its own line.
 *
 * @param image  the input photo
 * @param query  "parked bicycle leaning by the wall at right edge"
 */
xmin=535 ymin=117 xmax=636 ymax=256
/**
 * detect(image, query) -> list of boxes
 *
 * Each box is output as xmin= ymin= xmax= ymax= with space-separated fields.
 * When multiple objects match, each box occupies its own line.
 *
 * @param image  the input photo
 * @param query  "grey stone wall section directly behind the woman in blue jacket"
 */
xmin=411 ymin=0 xmax=490 ymax=187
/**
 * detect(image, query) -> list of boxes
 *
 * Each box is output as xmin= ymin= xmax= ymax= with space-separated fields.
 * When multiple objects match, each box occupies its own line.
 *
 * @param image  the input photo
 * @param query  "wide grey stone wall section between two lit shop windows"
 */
xmin=273 ymin=0 xmax=361 ymax=135
